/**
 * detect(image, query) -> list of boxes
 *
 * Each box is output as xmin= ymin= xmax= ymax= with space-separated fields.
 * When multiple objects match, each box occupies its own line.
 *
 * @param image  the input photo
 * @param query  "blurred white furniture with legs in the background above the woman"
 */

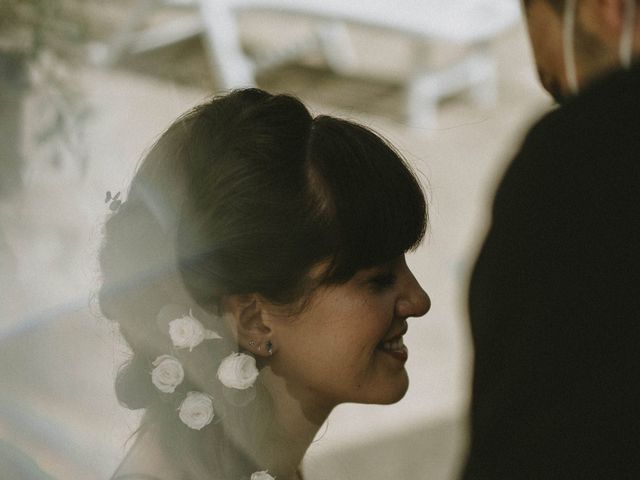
xmin=90 ymin=0 xmax=520 ymax=127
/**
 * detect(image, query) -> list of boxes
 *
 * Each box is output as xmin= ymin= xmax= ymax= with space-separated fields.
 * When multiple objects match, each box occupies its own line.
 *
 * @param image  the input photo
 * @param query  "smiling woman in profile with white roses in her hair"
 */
xmin=100 ymin=89 xmax=430 ymax=480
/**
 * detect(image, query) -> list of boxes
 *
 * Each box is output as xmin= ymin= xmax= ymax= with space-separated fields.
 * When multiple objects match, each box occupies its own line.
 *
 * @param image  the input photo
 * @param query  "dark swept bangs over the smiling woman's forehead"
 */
xmin=307 ymin=116 xmax=428 ymax=283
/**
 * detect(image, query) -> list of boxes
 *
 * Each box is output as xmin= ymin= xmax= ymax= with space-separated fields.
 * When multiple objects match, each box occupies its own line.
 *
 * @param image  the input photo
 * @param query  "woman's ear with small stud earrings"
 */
xmin=222 ymin=294 xmax=272 ymax=357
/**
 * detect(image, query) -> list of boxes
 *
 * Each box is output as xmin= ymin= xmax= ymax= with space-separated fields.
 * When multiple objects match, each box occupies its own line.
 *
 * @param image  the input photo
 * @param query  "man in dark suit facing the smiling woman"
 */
xmin=463 ymin=0 xmax=640 ymax=480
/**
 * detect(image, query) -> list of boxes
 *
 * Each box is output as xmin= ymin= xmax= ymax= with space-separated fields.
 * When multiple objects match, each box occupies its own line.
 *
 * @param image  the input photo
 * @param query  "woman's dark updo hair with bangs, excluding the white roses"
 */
xmin=99 ymin=89 xmax=427 ymax=478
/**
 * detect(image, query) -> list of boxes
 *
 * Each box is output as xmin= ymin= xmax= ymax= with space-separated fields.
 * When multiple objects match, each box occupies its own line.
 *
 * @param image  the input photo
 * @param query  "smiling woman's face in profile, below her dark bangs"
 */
xmin=270 ymin=255 xmax=431 ymax=408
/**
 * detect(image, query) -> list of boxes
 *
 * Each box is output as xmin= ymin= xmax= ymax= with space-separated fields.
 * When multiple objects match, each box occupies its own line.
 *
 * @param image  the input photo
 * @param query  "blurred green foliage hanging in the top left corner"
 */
xmin=0 ymin=0 xmax=90 ymax=178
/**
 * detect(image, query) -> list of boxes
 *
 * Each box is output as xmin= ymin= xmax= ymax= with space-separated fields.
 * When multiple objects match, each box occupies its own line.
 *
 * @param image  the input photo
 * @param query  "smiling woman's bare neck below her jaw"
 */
xmin=263 ymin=368 xmax=333 ymax=480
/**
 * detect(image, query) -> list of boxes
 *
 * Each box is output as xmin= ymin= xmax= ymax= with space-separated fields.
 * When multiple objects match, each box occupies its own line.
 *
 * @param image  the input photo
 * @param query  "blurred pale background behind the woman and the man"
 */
xmin=0 ymin=0 xmax=551 ymax=480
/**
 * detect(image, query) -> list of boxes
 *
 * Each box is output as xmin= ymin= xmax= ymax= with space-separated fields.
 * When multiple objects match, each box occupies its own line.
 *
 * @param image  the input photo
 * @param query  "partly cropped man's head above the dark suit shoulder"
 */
xmin=523 ymin=0 xmax=640 ymax=102
